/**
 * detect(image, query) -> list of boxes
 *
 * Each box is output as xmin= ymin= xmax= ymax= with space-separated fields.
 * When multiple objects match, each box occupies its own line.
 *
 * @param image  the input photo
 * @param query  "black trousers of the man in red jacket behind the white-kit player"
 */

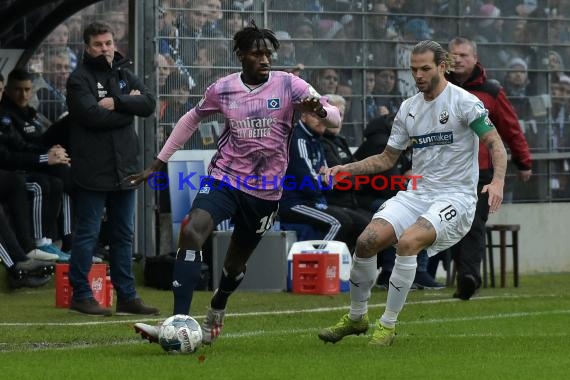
xmin=449 ymin=170 xmax=493 ymax=288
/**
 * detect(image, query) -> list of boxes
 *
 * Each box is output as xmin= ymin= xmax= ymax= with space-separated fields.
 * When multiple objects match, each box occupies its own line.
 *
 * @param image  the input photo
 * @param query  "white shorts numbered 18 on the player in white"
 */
xmin=372 ymin=191 xmax=477 ymax=256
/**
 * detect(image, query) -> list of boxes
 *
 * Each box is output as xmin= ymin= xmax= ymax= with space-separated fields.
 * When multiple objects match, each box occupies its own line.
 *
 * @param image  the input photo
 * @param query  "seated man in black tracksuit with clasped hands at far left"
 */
xmin=0 ymin=68 xmax=71 ymax=261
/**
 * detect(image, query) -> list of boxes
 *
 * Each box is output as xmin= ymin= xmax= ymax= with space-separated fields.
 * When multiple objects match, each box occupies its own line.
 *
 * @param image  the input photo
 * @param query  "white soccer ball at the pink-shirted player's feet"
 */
xmin=158 ymin=314 xmax=202 ymax=354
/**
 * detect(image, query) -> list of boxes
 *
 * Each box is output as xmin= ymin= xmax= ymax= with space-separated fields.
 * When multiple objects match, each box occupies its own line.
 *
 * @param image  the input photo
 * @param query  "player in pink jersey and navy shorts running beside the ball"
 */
xmin=129 ymin=22 xmax=340 ymax=344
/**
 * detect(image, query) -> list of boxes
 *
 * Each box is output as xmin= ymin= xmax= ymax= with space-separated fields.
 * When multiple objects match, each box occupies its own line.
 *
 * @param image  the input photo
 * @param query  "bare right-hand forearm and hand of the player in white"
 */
xmin=481 ymin=129 xmax=507 ymax=213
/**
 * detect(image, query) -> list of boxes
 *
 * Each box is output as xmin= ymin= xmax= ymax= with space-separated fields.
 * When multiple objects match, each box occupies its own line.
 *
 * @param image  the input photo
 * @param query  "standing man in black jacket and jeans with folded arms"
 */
xmin=67 ymin=22 xmax=159 ymax=316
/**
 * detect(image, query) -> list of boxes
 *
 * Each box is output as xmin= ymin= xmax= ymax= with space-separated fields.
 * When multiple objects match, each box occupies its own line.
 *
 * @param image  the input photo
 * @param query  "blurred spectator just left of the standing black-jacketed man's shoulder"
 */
xmin=37 ymin=49 xmax=71 ymax=123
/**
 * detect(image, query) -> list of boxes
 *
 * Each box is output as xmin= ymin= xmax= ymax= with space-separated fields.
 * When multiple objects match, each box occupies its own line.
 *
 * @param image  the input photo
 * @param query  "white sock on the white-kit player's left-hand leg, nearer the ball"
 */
xmin=349 ymin=254 xmax=378 ymax=321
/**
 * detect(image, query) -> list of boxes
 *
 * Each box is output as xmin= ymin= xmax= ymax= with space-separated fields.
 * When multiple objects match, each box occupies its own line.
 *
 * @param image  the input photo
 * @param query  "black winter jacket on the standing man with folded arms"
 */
xmin=67 ymin=53 xmax=156 ymax=191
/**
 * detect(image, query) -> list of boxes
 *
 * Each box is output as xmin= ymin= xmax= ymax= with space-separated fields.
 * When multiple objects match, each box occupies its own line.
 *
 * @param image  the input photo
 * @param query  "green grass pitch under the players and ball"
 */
xmin=0 ymin=274 xmax=570 ymax=380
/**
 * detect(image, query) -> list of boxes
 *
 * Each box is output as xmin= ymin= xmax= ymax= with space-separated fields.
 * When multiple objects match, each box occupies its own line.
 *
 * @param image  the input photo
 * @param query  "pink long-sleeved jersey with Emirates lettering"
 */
xmin=158 ymin=71 xmax=340 ymax=200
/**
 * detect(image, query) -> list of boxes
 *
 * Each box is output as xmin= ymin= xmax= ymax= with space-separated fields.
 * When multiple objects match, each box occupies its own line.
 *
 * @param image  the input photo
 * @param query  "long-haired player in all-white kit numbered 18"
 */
xmin=319 ymin=40 xmax=507 ymax=346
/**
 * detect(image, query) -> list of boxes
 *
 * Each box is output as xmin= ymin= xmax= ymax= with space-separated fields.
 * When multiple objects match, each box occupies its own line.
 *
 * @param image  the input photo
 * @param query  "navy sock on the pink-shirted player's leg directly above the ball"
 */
xmin=172 ymin=249 xmax=202 ymax=315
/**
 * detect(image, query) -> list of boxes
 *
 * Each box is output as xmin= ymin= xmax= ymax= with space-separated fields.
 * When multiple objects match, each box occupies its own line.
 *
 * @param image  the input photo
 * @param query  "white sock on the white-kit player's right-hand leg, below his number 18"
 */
xmin=380 ymin=255 xmax=418 ymax=328
